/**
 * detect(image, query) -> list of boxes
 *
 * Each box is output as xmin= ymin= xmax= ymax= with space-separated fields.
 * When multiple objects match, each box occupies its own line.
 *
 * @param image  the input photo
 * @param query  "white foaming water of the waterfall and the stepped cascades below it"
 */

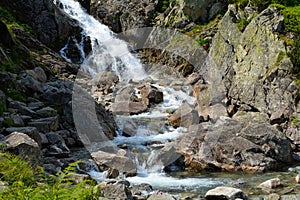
xmin=54 ymin=0 xmax=232 ymax=197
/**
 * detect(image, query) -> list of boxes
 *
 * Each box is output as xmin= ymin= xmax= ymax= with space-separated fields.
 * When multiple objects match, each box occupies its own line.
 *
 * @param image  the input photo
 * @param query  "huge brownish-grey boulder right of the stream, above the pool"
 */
xmin=178 ymin=118 xmax=292 ymax=172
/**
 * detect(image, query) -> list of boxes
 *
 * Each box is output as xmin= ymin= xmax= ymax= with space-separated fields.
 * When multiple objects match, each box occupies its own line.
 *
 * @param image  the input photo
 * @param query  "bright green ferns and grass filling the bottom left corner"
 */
xmin=0 ymin=152 xmax=100 ymax=200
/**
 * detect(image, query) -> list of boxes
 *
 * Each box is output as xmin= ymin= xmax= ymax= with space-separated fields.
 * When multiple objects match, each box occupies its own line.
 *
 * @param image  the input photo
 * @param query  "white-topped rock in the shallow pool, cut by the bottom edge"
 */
xmin=205 ymin=187 xmax=248 ymax=200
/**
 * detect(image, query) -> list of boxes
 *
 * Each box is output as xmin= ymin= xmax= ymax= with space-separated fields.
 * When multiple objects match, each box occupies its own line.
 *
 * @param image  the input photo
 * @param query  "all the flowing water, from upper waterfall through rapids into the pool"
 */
xmin=54 ymin=0 xmax=300 ymax=198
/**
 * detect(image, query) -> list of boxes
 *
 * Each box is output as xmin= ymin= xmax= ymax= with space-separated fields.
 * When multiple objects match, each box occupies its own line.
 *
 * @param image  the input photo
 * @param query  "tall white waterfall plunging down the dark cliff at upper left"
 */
xmin=54 ymin=0 xmax=146 ymax=80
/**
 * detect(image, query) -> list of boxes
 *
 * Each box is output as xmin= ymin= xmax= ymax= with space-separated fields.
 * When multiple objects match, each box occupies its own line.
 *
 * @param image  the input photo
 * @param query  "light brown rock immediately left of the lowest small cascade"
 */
xmin=91 ymin=151 xmax=137 ymax=174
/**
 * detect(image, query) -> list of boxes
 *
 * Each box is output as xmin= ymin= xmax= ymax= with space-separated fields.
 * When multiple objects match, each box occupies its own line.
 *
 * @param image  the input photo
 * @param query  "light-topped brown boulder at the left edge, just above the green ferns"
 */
xmin=2 ymin=132 xmax=42 ymax=165
